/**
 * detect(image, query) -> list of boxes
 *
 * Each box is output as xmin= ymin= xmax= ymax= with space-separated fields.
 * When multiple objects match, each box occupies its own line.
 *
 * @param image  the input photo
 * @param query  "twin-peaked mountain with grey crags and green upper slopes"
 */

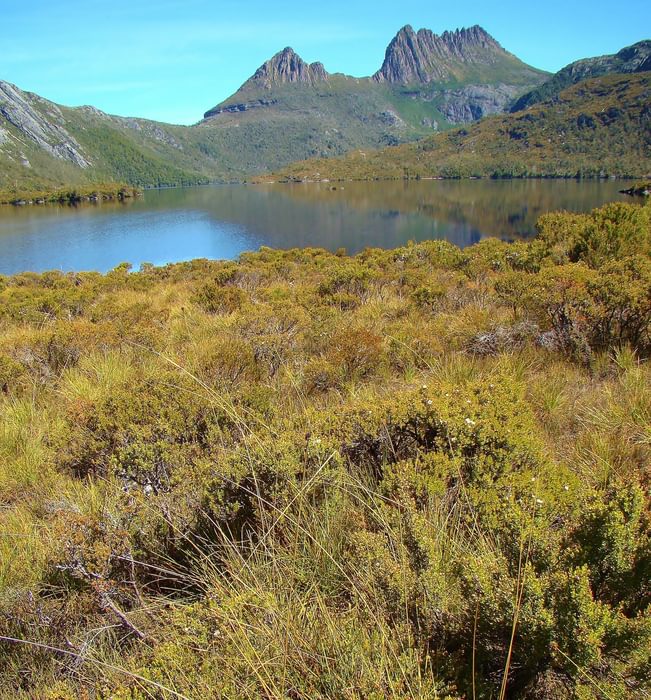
xmin=204 ymin=25 xmax=547 ymax=141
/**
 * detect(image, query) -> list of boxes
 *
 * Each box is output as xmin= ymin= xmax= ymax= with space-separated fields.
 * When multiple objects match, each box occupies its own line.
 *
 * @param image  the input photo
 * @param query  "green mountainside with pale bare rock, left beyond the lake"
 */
xmin=0 ymin=89 xmax=216 ymax=190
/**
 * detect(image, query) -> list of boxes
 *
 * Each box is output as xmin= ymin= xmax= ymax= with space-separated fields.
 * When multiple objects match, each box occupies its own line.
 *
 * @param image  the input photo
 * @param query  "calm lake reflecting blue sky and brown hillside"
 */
xmin=0 ymin=180 xmax=630 ymax=274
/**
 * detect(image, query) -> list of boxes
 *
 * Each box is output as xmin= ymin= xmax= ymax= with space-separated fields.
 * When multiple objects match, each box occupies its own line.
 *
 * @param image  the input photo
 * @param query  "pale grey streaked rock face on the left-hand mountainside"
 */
xmin=0 ymin=81 xmax=91 ymax=168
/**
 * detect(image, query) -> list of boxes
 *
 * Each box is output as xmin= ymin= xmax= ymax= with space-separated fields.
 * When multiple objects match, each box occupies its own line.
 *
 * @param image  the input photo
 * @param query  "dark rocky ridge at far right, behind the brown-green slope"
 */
xmin=510 ymin=39 xmax=651 ymax=112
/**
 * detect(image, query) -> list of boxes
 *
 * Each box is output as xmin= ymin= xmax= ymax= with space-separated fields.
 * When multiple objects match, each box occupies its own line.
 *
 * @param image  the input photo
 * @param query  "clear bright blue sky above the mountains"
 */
xmin=0 ymin=0 xmax=651 ymax=124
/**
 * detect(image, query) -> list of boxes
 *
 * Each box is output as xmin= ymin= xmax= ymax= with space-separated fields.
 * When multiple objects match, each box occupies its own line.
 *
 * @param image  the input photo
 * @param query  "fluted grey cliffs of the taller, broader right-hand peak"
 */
xmin=373 ymin=25 xmax=510 ymax=85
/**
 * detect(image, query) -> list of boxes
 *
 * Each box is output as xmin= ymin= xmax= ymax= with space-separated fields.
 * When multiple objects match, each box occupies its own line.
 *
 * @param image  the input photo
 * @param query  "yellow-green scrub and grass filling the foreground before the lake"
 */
xmin=0 ymin=204 xmax=651 ymax=700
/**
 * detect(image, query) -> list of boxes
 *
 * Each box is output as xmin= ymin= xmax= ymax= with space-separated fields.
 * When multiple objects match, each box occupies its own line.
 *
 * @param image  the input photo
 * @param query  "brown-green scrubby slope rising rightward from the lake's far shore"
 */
xmin=274 ymin=72 xmax=651 ymax=180
